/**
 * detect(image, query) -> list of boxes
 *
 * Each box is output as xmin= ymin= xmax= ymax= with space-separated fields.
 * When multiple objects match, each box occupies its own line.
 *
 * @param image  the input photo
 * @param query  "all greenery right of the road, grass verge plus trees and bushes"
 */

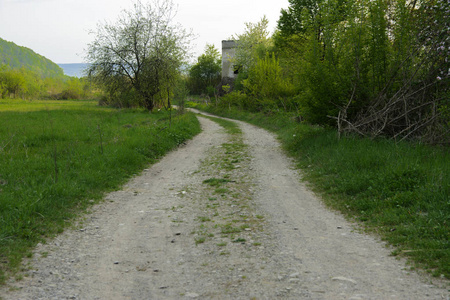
xmin=178 ymin=0 xmax=450 ymax=279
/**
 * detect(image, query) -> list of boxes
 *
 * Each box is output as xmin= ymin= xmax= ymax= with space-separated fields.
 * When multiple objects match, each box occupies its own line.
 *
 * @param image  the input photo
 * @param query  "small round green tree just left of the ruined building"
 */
xmin=189 ymin=44 xmax=222 ymax=96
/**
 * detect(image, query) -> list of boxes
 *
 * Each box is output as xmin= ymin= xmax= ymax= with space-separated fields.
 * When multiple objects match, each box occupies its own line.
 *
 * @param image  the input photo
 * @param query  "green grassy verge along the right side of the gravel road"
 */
xmin=188 ymin=101 xmax=450 ymax=279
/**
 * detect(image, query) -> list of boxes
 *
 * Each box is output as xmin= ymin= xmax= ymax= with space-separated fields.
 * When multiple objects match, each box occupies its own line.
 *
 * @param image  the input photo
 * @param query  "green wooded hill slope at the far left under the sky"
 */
xmin=0 ymin=38 xmax=64 ymax=78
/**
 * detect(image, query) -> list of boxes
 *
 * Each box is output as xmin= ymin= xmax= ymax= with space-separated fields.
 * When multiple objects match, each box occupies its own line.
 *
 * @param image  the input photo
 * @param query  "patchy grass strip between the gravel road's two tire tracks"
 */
xmin=189 ymin=115 xmax=264 ymax=254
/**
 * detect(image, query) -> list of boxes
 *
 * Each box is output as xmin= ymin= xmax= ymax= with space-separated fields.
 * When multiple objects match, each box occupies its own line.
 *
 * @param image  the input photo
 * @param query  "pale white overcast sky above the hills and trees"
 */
xmin=0 ymin=0 xmax=289 ymax=63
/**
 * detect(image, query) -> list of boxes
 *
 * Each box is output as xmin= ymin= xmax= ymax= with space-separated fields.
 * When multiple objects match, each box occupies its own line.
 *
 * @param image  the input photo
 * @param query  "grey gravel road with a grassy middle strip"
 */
xmin=0 ymin=113 xmax=449 ymax=299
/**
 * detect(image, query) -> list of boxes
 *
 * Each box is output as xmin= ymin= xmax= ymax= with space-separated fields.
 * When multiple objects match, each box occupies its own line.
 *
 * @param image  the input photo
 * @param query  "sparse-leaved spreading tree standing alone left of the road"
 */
xmin=86 ymin=0 xmax=192 ymax=111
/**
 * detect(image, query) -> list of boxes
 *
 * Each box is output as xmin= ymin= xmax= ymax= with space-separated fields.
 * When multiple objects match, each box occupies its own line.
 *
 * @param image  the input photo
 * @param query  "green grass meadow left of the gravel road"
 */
xmin=0 ymin=100 xmax=200 ymax=283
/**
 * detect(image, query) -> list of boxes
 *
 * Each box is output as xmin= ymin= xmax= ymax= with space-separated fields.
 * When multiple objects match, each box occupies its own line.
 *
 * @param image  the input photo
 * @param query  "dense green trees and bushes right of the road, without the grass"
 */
xmin=185 ymin=0 xmax=450 ymax=145
